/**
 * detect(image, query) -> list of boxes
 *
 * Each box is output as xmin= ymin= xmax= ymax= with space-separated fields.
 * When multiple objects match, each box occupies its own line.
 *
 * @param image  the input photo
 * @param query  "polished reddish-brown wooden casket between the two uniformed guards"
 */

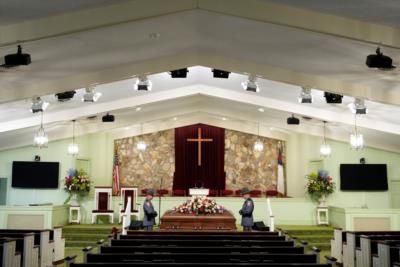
xmin=160 ymin=210 xmax=236 ymax=231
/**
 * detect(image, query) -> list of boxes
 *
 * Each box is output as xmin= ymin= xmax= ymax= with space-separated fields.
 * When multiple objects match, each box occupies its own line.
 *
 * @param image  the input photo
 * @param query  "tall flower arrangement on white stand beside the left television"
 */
xmin=64 ymin=169 xmax=91 ymax=205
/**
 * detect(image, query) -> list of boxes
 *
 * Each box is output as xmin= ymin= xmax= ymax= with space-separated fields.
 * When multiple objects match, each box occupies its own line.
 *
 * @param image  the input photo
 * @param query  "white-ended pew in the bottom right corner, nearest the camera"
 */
xmin=372 ymin=240 xmax=400 ymax=267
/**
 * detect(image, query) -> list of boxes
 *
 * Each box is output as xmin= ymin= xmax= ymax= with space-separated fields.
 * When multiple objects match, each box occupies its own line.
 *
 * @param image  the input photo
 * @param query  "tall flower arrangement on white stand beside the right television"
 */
xmin=306 ymin=171 xmax=336 ymax=206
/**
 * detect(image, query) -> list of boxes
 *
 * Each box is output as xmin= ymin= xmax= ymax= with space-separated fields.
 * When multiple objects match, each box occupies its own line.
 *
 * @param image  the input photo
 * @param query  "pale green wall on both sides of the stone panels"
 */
xmin=0 ymin=129 xmax=400 ymax=221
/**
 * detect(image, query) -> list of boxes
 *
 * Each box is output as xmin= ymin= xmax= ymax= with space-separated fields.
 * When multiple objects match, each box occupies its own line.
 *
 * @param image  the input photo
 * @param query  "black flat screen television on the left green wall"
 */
xmin=11 ymin=161 xmax=60 ymax=189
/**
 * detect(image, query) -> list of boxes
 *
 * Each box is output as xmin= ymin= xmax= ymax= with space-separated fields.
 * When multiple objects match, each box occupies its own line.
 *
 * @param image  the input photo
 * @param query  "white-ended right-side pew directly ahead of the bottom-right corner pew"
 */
xmin=356 ymin=235 xmax=400 ymax=267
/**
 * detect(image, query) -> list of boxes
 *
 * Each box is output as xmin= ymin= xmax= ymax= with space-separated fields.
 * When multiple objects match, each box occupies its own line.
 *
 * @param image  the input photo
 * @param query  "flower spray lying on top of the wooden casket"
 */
xmin=174 ymin=196 xmax=224 ymax=214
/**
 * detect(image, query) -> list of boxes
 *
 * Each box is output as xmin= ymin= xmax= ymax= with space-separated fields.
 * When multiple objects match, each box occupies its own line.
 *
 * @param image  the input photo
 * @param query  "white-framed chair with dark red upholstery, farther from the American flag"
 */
xmin=92 ymin=186 xmax=114 ymax=223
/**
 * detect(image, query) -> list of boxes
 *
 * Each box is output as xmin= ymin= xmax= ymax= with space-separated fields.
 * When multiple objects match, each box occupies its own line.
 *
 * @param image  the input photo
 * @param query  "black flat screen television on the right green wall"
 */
xmin=340 ymin=164 xmax=388 ymax=191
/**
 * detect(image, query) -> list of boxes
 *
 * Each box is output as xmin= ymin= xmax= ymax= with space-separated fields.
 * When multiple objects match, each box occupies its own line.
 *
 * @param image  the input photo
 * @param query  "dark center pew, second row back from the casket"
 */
xmin=120 ymin=235 xmax=285 ymax=240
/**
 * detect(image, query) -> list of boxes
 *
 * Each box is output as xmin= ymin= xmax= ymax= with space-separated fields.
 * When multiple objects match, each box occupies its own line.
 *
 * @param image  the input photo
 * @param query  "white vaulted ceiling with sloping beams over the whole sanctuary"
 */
xmin=0 ymin=0 xmax=400 ymax=151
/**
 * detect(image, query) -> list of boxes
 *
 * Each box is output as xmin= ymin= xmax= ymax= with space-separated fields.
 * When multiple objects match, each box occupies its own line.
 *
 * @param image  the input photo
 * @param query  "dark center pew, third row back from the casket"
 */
xmin=111 ymin=239 xmax=294 ymax=247
